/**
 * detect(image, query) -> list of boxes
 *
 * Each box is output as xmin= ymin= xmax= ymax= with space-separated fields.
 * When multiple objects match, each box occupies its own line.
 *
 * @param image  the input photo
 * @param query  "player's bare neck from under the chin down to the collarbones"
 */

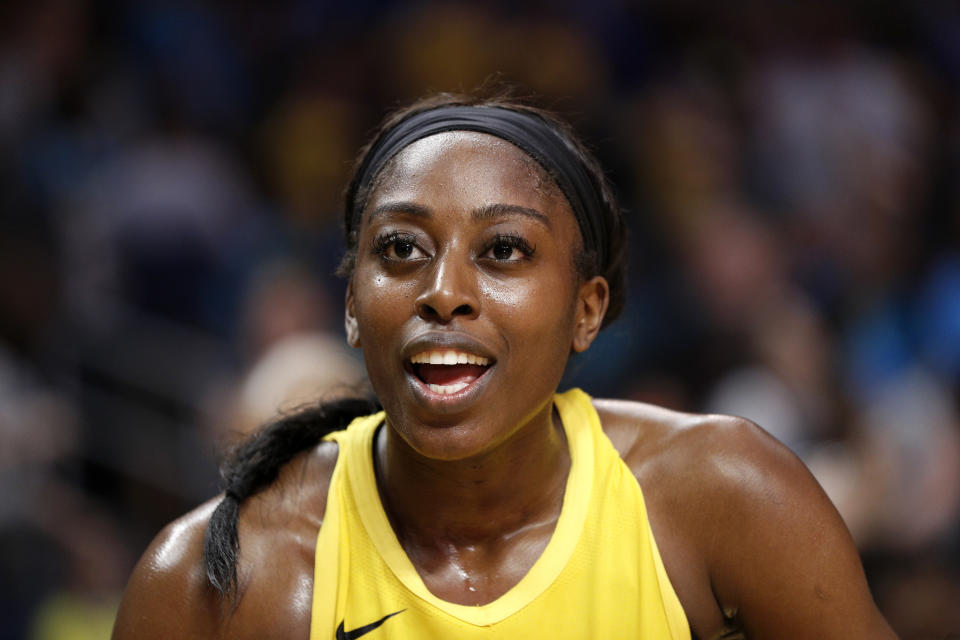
xmin=375 ymin=402 xmax=570 ymax=550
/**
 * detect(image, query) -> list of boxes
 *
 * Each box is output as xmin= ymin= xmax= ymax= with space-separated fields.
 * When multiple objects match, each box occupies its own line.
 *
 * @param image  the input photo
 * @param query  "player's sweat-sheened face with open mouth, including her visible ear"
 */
xmin=346 ymin=132 xmax=607 ymax=460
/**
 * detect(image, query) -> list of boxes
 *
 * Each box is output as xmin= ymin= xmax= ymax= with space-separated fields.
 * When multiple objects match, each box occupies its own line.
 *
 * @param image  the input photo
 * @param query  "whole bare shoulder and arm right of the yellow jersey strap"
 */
xmin=595 ymin=400 xmax=894 ymax=638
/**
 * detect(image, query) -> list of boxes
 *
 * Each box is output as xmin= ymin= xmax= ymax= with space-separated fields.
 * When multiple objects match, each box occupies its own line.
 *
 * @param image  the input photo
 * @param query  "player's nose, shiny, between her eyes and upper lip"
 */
xmin=415 ymin=252 xmax=480 ymax=324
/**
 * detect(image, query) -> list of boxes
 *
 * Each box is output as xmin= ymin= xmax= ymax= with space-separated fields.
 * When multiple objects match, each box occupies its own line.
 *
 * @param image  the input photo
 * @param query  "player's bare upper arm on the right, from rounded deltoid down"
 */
xmin=700 ymin=419 xmax=894 ymax=639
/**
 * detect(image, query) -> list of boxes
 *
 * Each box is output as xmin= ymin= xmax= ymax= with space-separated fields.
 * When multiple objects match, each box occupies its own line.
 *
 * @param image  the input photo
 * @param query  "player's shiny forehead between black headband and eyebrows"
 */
xmin=366 ymin=131 xmax=573 ymax=218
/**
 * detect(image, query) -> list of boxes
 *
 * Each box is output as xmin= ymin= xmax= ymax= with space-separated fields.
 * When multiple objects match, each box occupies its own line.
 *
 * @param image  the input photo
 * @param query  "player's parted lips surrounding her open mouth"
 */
xmin=401 ymin=331 xmax=497 ymax=414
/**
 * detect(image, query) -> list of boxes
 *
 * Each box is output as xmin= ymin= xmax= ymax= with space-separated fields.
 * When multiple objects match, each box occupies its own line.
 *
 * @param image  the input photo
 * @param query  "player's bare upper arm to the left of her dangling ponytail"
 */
xmin=113 ymin=503 xmax=220 ymax=640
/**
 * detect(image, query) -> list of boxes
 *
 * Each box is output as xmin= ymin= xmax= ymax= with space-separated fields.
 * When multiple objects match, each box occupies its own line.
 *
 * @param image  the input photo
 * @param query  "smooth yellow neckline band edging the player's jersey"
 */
xmin=347 ymin=389 xmax=600 ymax=626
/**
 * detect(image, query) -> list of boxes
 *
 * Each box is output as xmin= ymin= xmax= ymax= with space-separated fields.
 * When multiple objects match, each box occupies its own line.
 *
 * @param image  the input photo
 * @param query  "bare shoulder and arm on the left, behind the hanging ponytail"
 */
xmin=113 ymin=443 xmax=337 ymax=640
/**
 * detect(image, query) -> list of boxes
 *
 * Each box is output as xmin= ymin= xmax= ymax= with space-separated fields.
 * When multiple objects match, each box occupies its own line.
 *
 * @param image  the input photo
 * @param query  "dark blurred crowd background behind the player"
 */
xmin=0 ymin=0 xmax=960 ymax=640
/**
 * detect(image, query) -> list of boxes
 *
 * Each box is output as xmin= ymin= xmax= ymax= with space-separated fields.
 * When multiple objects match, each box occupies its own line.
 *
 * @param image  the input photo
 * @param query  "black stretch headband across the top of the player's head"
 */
xmin=350 ymin=106 xmax=608 ymax=269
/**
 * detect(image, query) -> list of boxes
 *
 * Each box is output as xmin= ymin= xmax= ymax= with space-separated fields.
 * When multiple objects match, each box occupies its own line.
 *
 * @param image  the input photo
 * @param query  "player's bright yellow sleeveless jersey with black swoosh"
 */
xmin=310 ymin=389 xmax=690 ymax=640
